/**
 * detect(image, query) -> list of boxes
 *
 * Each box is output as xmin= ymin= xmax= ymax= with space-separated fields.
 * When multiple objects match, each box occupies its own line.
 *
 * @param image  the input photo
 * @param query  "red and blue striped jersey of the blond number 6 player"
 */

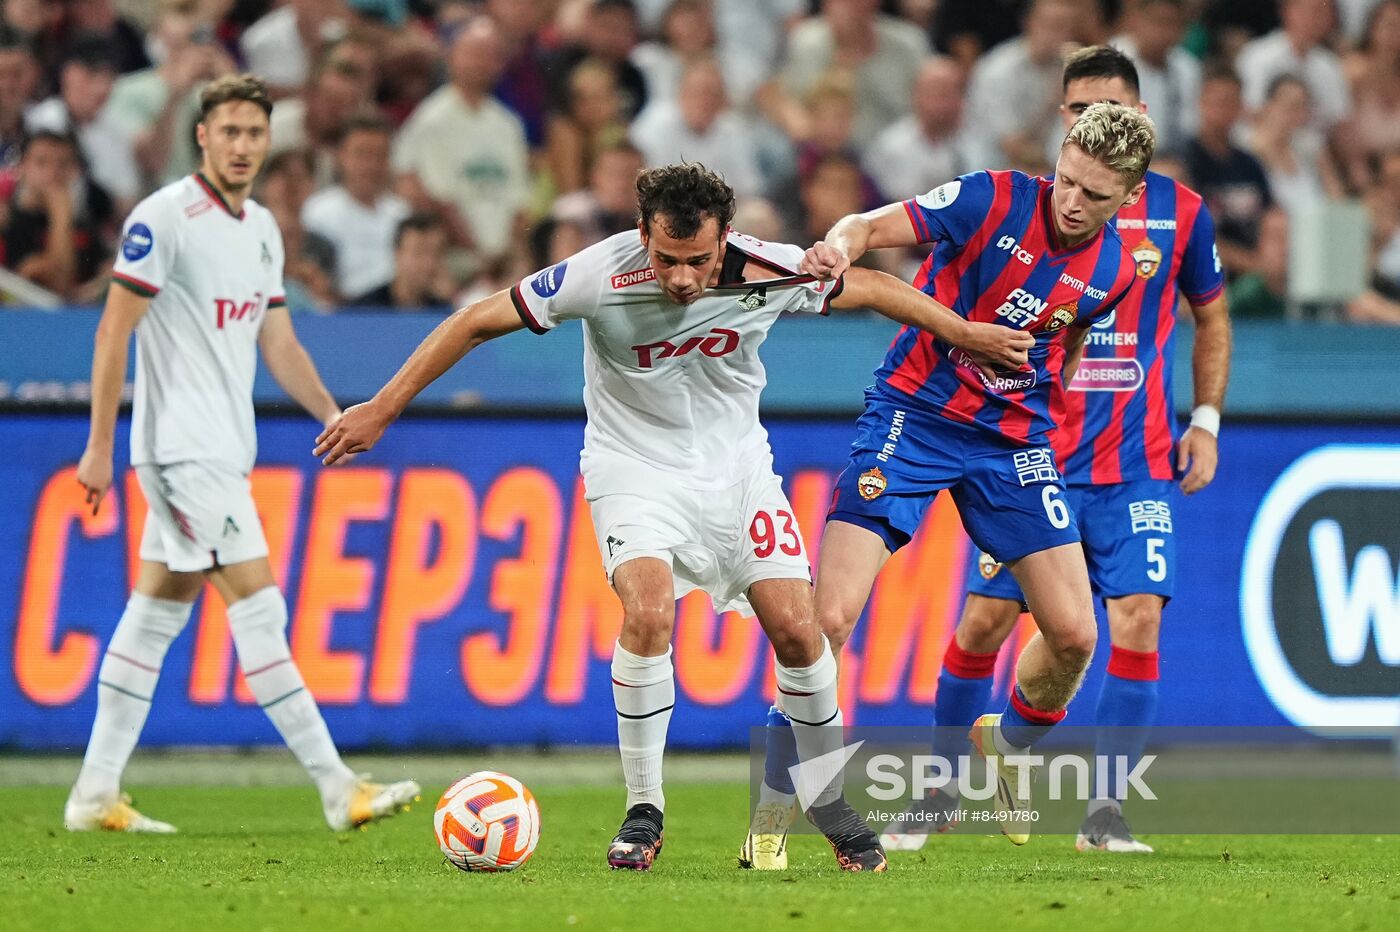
xmin=875 ymin=172 xmax=1135 ymax=445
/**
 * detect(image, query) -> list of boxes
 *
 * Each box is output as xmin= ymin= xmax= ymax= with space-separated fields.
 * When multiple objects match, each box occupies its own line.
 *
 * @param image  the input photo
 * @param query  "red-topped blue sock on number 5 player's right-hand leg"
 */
xmin=1093 ymin=647 xmax=1158 ymax=803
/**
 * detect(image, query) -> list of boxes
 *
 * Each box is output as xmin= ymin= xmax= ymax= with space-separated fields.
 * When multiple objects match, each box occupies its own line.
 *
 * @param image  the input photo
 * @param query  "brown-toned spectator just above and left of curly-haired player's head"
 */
xmin=545 ymin=59 xmax=627 ymax=193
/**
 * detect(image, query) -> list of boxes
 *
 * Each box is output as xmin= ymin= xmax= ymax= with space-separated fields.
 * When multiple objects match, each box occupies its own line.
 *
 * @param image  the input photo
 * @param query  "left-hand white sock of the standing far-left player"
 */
xmin=74 ymin=592 xmax=193 ymax=800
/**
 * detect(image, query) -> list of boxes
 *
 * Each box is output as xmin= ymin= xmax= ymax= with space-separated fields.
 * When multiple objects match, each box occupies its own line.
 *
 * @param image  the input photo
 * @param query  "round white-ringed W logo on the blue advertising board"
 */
xmin=1239 ymin=444 xmax=1400 ymax=735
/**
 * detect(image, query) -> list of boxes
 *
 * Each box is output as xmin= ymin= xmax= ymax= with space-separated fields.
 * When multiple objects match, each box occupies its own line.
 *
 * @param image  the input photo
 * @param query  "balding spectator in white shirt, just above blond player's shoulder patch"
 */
xmin=861 ymin=56 xmax=974 ymax=202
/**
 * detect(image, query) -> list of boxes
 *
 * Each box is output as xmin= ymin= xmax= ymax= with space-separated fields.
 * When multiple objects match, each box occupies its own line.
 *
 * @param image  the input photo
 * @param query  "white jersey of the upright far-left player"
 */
xmin=112 ymin=175 xmax=286 ymax=473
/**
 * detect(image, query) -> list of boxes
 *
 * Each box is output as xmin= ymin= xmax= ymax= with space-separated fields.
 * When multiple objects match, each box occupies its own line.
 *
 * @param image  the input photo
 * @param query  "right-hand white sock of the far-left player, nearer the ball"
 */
xmin=228 ymin=586 xmax=354 ymax=799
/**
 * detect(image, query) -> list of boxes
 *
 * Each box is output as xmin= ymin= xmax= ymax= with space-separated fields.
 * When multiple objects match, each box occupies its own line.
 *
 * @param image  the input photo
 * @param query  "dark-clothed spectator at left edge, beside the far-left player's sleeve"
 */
xmin=4 ymin=130 xmax=113 ymax=304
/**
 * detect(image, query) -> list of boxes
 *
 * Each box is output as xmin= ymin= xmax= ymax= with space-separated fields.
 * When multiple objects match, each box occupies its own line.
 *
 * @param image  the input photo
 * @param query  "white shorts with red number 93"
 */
xmin=585 ymin=460 xmax=812 ymax=616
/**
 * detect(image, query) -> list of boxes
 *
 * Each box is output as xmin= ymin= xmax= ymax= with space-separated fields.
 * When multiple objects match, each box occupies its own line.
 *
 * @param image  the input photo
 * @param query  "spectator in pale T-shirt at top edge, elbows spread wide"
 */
xmin=766 ymin=0 xmax=928 ymax=144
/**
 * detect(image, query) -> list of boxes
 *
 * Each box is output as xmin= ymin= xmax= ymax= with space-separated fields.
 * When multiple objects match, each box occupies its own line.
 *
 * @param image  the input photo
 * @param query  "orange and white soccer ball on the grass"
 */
xmin=433 ymin=770 xmax=539 ymax=872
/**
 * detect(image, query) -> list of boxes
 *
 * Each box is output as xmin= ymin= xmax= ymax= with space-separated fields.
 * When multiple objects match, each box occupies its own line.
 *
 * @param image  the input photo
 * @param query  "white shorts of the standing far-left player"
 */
xmin=136 ymin=462 xmax=267 ymax=572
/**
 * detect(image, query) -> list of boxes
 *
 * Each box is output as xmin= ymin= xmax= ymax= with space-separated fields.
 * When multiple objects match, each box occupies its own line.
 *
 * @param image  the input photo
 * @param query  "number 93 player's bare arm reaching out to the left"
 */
xmin=312 ymin=291 xmax=525 ymax=466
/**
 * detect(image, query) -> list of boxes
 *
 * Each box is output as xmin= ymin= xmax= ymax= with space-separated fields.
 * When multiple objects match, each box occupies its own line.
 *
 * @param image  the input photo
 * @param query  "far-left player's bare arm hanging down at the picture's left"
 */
xmin=78 ymin=284 xmax=151 ymax=515
